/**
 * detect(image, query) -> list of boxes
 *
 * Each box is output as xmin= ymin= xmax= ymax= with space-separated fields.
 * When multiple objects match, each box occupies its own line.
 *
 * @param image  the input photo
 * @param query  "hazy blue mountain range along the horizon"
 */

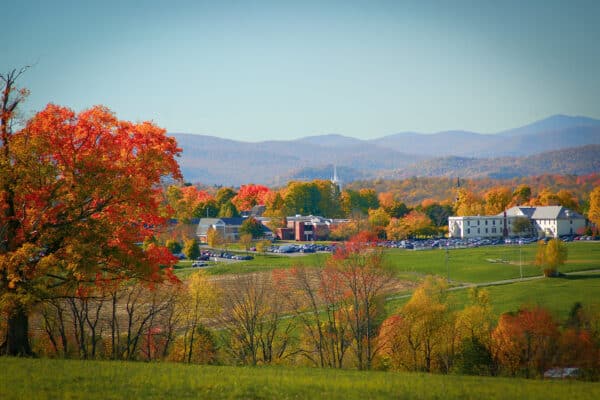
xmin=170 ymin=115 xmax=600 ymax=186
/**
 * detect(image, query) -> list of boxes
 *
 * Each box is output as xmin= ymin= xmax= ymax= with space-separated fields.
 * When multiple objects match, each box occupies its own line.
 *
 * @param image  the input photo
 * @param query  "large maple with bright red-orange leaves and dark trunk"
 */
xmin=0 ymin=74 xmax=181 ymax=355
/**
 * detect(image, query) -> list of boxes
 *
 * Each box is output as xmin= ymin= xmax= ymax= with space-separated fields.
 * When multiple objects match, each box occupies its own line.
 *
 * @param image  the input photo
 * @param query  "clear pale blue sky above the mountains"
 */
xmin=0 ymin=0 xmax=600 ymax=141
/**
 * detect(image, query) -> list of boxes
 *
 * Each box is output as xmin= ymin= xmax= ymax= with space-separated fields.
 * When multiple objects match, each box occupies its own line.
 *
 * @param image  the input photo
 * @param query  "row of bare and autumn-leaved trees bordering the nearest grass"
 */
xmin=9 ymin=238 xmax=600 ymax=380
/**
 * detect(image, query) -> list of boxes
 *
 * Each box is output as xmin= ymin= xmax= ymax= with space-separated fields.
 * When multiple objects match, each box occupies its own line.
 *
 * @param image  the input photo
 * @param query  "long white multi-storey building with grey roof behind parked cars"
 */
xmin=448 ymin=206 xmax=586 ymax=238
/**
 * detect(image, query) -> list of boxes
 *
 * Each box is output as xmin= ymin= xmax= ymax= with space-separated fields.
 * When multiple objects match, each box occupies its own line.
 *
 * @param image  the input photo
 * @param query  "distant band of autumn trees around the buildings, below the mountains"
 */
xmin=166 ymin=180 xmax=600 ymax=240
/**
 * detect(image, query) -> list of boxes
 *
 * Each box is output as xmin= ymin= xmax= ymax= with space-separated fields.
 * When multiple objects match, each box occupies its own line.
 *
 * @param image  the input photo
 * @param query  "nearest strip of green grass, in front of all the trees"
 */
xmin=0 ymin=357 xmax=600 ymax=400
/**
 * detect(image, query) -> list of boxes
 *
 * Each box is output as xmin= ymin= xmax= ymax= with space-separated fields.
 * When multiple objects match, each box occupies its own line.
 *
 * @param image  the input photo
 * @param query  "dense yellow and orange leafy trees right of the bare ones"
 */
xmin=379 ymin=277 xmax=600 ymax=379
